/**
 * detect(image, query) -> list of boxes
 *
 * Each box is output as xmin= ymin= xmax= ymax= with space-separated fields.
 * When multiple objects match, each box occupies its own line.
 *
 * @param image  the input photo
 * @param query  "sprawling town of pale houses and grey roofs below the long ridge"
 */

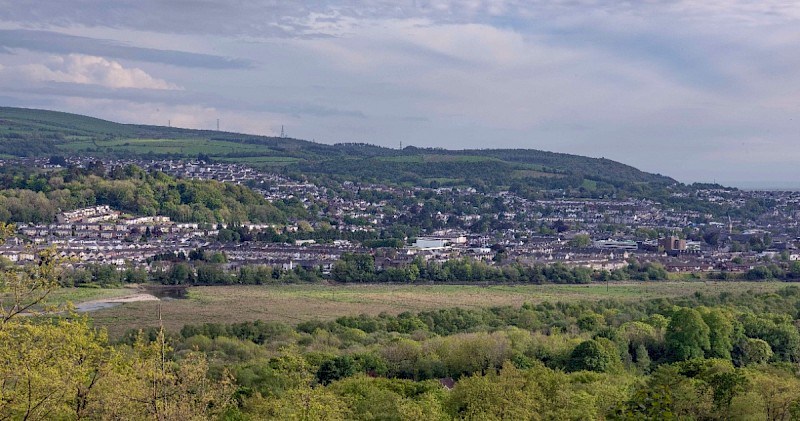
xmin=0 ymin=158 xmax=800 ymax=273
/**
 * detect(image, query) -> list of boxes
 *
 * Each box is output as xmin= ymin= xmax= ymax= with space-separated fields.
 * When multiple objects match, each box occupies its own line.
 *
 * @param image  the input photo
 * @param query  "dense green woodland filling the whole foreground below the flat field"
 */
xmin=0 ymin=244 xmax=800 ymax=420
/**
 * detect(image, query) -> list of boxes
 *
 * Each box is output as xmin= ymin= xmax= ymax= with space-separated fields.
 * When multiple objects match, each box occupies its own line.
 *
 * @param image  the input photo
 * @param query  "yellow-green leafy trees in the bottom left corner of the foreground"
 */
xmin=0 ymin=243 xmax=232 ymax=419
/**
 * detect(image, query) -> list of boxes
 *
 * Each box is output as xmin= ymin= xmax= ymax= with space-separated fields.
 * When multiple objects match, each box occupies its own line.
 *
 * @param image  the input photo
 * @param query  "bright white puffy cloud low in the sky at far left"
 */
xmin=0 ymin=54 xmax=181 ymax=90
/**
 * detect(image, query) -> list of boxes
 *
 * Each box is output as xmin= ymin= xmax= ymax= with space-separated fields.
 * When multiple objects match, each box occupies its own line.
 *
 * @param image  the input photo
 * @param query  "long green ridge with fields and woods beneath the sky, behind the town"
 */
xmin=0 ymin=107 xmax=676 ymax=192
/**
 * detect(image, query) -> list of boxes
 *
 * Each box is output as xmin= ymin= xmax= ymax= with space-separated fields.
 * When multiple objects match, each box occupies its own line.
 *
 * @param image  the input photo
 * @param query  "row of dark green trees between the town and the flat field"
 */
xmin=59 ymin=249 xmax=667 ymax=287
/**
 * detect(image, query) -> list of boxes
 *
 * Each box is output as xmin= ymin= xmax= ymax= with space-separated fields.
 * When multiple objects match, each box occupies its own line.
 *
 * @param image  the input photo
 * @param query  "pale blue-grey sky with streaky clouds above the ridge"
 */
xmin=0 ymin=0 xmax=800 ymax=187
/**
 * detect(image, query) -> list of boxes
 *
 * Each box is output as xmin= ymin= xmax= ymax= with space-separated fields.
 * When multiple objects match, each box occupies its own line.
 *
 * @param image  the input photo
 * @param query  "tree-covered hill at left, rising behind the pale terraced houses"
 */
xmin=0 ymin=161 xmax=307 ymax=224
